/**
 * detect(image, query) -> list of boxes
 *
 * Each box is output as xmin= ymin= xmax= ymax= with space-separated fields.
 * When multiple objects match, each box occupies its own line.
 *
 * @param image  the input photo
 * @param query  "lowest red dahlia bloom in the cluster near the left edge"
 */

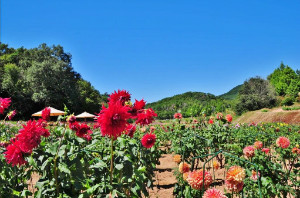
xmin=4 ymin=141 xmax=27 ymax=167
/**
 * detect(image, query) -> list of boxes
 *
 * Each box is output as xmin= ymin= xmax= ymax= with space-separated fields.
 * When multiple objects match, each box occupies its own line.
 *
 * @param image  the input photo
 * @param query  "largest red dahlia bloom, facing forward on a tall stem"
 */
xmin=97 ymin=102 xmax=131 ymax=138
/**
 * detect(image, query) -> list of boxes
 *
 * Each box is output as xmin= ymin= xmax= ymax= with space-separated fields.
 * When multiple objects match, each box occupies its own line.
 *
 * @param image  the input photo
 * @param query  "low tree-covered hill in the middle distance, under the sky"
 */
xmin=147 ymin=92 xmax=228 ymax=119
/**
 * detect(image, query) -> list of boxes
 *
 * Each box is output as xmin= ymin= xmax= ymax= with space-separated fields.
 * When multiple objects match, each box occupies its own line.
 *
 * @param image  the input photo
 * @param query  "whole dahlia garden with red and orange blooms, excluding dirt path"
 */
xmin=0 ymin=90 xmax=300 ymax=198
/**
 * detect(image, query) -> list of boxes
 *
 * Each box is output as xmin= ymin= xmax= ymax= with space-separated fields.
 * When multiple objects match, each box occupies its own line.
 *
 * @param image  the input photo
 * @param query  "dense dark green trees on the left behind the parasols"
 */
xmin=0 ymin=43 xmax=107 ymax=119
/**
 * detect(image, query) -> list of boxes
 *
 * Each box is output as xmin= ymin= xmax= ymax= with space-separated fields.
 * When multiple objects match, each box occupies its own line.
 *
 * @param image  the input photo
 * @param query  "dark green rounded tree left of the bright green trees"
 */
xmin=234 ymin=77 xmax=276 ymax=115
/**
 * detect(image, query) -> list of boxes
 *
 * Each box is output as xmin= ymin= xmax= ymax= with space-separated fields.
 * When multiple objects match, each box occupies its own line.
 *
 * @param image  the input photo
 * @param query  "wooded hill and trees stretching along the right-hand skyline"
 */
xmin=148 ymin=63 xmax=300 ymax=119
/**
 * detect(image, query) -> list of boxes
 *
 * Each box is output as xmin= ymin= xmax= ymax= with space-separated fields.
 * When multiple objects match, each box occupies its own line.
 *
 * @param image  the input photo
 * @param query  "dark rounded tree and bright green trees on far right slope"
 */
xmin=233 ymin=63 xmax=300 ymax=115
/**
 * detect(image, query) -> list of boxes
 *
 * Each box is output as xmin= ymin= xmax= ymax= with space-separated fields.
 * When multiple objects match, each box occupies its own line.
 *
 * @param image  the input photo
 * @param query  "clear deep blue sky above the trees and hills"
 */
xmin=1 ymin=0 xmax=300 ymax=102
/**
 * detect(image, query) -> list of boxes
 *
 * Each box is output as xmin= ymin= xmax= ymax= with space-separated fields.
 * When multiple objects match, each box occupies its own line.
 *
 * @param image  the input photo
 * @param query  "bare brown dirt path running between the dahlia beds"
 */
xmin=149 ymin=154 xmax=177 ymax=198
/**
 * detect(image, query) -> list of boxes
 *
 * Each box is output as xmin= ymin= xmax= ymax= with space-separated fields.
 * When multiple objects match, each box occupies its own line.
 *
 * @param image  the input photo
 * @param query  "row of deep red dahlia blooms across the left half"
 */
xmin=0 ymin=90 xmax=157 ymax=166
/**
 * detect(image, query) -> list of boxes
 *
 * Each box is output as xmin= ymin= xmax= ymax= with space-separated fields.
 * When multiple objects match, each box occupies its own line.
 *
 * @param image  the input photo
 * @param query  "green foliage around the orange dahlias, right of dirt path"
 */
xmin=171 ymin=115 xmax=300 ymax=198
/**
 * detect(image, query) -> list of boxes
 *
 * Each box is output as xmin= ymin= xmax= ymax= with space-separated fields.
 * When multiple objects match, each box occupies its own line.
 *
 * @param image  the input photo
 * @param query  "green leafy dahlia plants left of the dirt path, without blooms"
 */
xmin=0 ymin=123 xmax=163 ymax=198
